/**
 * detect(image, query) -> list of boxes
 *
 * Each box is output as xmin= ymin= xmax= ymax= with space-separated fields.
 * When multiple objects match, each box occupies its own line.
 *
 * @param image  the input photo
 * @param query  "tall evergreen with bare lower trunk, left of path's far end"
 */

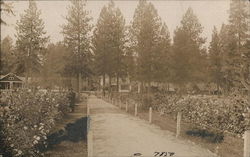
xmin=62 ymin=0 xmax=92 ymax=92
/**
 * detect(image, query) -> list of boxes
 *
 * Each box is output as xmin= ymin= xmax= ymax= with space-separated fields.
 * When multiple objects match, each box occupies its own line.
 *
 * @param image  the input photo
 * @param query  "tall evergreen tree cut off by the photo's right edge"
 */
xmin=229 ymin=0 xmax=250 ymax=91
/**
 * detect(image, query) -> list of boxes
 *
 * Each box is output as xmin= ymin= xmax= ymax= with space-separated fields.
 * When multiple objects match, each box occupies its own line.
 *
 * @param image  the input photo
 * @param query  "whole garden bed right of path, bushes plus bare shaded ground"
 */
xmin=109 ymin=93 xmax=249 ymax=157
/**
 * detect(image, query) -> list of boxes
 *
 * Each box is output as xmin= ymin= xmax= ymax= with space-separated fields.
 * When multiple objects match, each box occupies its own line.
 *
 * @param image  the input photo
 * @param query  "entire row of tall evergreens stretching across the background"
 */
xmin=0 ymin=0 xmax=250 ymax=92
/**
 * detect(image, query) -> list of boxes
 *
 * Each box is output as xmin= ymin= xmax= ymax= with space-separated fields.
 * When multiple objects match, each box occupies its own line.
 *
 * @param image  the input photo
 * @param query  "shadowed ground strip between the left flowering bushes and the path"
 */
xmin=46 ymin=100 xmax=87 ymax=157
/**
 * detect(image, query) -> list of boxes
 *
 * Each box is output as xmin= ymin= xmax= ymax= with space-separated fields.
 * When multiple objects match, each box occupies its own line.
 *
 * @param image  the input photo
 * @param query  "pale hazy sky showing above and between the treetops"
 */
xmin=1 ymin=0 xmax=230 ymax=44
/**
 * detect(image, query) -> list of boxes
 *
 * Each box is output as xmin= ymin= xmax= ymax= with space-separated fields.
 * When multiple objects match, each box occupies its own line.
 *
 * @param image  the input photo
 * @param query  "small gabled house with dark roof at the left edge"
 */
xmin=0 ymin=73 xmax=24 ymax=89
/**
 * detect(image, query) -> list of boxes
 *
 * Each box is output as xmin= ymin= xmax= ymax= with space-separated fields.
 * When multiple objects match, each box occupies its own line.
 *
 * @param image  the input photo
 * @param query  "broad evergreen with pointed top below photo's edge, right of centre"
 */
xmin=171 ymin=8 xmax=207 ymax=89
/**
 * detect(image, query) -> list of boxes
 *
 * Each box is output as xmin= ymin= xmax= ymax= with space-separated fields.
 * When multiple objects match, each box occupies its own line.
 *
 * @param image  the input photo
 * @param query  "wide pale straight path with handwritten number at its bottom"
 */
xmin=88 ymin=96 xmax=215 ymax=157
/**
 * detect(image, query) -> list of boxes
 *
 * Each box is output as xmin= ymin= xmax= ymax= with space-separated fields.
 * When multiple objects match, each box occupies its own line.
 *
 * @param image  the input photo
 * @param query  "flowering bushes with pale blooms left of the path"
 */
xmin=0 ymin=90 xmax=69 ymax=156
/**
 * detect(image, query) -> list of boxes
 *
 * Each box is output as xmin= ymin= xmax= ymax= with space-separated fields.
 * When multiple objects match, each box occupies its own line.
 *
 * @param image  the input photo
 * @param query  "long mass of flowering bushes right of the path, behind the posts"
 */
xmin=116 ymin=92 xmax=250 ymax=135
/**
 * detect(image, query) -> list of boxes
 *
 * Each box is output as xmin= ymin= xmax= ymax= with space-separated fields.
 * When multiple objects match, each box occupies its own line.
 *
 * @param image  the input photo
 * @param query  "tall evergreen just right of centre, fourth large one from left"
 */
xmin=130 ymin=0 xmax=164 ymax=85
